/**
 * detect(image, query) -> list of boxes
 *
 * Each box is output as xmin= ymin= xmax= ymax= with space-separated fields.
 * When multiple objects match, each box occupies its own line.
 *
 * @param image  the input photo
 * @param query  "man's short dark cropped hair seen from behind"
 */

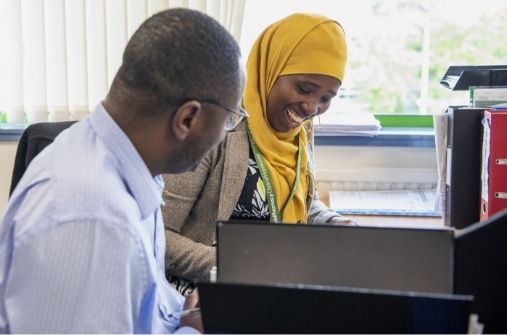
xmin=113 ymin=8 xmax=241 ymax=113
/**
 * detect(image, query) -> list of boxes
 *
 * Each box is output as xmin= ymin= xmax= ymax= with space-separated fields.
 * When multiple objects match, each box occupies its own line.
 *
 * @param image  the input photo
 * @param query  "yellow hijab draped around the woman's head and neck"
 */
xmin=243 ymin=14 xmax=347 ymax=223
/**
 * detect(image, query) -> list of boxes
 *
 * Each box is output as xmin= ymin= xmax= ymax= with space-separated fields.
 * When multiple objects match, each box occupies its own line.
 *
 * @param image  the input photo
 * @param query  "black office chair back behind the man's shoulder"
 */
xmin=9 ymin=121 xmax=77 ymax=197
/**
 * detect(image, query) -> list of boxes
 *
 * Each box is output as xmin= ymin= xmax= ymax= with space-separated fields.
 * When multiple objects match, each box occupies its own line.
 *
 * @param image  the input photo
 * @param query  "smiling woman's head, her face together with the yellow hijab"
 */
xmin=244 ymin=14 xmax=347 ymax=222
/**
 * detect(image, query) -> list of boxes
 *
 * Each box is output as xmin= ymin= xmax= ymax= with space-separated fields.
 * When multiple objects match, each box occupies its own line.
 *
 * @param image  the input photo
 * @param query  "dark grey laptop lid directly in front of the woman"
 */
xmin=216 ymin=221 xmax=454 ymax=294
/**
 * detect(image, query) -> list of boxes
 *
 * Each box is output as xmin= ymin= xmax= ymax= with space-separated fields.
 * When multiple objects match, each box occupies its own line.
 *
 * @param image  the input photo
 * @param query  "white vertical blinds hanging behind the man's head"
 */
xmin=0 ymin=0 xmax=245 ymax=123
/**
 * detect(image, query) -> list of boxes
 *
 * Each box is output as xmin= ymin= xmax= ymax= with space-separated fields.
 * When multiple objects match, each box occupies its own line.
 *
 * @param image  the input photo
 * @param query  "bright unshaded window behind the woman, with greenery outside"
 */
xmin=240 ymin=0 xmax=507 ymax=125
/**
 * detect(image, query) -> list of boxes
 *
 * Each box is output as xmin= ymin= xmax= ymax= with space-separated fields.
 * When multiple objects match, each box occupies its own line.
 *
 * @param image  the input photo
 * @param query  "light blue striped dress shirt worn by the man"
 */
xmin=0 ymin=104 xmax=197 ymax=333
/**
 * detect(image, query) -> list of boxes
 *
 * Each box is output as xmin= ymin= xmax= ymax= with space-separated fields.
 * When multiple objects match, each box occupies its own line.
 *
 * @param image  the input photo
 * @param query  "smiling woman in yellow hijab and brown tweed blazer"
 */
xmin=162 ymin=14 xmax=353 ymax=294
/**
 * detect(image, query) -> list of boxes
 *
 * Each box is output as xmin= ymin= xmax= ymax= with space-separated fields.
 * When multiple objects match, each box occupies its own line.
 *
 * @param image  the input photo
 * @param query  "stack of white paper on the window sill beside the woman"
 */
xmin=314 ymin=112 xmax=382 ymax=136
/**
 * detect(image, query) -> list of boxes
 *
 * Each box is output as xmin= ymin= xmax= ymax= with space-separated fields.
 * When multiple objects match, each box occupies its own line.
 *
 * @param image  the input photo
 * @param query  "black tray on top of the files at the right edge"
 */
xmin=440 ymin=65 xmax=507 ymax=91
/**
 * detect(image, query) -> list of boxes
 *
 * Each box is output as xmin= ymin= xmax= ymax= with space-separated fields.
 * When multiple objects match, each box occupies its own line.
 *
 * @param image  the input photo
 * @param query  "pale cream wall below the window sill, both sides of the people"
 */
xmin=0 ymin=141 xmax=437 ymax=213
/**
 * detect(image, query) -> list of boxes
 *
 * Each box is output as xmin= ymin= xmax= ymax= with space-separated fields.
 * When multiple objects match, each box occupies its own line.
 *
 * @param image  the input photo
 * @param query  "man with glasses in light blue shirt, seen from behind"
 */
xmin=0 ymin=9 xmax=244 ymax=333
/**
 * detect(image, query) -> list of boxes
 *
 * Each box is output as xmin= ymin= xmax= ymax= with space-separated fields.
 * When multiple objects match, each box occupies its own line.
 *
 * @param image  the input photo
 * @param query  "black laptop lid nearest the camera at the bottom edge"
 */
xmin=197 ymin=282 xmax=472 ymax=334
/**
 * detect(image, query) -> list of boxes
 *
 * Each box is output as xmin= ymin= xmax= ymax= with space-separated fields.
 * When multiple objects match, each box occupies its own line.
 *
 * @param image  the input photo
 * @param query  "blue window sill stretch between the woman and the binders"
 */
xmin=315 ymin=127 xmax=435 ymax=148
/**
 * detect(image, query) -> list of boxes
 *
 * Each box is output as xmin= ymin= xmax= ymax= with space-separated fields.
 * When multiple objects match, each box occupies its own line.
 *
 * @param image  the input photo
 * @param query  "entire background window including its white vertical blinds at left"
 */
xmin=0 ymin=0 xmax=507 ymax=126
